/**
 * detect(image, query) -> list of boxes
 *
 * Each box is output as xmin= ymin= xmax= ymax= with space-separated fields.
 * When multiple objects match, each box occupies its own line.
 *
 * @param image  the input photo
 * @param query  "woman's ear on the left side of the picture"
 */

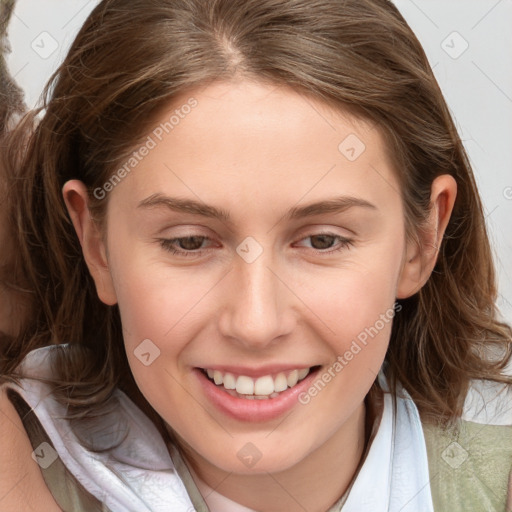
xmin=62 ymin=180 xmax=117 ymax=306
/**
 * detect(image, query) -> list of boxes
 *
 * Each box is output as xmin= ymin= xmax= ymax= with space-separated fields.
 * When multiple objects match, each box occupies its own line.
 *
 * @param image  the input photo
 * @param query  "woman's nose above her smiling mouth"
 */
xmin=219 ymin=253 xmax=296 ymax=350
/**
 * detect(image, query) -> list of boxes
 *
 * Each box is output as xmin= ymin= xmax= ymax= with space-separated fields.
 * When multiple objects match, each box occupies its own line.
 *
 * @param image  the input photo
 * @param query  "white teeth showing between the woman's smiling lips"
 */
xmin=200 ymin=366 xmax=320 ymax=400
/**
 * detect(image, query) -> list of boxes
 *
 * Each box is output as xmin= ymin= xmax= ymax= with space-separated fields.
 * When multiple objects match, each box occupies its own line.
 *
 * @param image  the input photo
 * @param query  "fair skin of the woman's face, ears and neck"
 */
xmin=63 ymin=81 xmax=456 ymax=512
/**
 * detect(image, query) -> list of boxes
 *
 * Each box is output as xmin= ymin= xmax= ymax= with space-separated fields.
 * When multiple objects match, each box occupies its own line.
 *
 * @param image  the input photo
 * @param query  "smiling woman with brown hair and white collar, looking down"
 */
xmin=0 ymin=0 xmax=512 ymax=512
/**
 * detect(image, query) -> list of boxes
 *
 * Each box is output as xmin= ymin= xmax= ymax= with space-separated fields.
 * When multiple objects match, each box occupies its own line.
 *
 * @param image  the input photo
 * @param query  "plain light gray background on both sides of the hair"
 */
xmin=8 ymin=0 xmax=512 ymax=322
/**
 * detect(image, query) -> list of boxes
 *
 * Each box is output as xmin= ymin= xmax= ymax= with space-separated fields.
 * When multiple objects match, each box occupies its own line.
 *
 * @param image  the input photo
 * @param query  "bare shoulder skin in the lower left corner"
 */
xmin=0 ymin=386 xmax=61 ymax=512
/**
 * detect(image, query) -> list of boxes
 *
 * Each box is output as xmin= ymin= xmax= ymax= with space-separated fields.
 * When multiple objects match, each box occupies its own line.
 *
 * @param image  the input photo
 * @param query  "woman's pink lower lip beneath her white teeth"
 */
xmin=194 ymin=368 xmax=318 ymax=422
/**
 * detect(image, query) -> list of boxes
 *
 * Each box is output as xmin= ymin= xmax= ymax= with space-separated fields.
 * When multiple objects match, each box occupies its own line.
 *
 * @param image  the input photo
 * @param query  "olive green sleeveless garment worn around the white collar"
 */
xmin=9 ymin=393 xmax=512 ymax=512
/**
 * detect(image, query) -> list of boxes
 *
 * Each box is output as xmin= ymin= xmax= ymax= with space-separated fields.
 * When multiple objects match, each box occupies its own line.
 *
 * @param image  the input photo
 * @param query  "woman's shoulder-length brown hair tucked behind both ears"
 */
xmin=0 ymin=0 xmax=512 ymax=426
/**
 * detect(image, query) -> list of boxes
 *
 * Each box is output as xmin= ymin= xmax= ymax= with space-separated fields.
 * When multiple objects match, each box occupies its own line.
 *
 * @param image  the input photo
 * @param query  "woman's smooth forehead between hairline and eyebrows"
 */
xmin=110 ymin=81 xmax=398 ymax=216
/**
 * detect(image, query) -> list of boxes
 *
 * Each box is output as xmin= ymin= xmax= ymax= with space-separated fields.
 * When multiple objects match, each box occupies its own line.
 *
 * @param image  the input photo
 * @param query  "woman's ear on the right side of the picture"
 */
xmin=396 ymin=174 xmax=457 ymax=299
